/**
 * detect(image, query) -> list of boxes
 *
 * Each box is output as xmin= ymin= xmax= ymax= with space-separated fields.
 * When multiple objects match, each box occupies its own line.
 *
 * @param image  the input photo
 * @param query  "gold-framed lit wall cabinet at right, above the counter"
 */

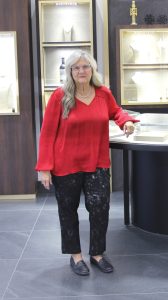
xmin=116 ymin=25 xmax=168 ymax=106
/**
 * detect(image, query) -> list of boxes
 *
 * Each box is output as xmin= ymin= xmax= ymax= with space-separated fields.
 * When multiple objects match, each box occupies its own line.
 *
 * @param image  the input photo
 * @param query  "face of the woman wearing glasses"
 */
xmin=71 ymin=58 xmax=92 ymax=85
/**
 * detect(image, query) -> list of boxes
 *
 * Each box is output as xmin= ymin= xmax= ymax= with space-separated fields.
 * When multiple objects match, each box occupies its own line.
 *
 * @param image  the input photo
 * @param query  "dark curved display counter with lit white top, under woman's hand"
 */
xmin=110 ymin=114 xmax=168 ymax=234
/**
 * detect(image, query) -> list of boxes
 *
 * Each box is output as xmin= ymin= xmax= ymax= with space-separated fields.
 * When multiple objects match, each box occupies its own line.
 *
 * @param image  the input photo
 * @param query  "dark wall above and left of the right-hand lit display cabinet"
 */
xmin=108 ymin=0 xmax=168 ymax=105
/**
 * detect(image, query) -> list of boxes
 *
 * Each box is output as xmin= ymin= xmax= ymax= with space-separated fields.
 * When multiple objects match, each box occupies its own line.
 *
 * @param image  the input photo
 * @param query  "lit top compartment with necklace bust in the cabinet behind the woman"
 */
xmin=42 ymin=3 xmax=91 ymax=42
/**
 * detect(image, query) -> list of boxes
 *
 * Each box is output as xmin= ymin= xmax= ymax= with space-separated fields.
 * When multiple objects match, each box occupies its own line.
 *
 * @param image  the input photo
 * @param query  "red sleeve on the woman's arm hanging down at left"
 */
xmin=35 ymin=89 xmax=63 ymax=171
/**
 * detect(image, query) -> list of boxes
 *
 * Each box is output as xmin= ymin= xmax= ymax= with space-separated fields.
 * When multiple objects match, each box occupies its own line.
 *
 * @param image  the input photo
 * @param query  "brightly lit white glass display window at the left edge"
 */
xmin=0 ymin=31 xmax=19 ymax=114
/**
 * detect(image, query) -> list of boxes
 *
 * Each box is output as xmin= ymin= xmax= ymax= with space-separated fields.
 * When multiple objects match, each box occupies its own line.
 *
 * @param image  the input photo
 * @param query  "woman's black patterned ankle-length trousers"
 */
xmin=52 ymin=168 xmax=110 ymax=256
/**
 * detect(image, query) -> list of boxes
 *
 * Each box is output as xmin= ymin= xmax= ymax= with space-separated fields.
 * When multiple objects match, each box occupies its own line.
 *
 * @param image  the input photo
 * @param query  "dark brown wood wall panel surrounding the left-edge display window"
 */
xmin=0 ymin=0 xmax=36 ymax=195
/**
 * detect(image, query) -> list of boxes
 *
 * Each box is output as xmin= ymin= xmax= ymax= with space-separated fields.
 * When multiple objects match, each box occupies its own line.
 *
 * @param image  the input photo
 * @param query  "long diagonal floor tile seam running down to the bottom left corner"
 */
xmin=1 ymin=195 xmax=48 ymax=300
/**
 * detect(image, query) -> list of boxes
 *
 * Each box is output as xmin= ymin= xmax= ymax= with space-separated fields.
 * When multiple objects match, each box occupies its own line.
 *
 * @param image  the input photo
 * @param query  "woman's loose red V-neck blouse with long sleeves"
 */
xmin=36 ymin=86 xmax=135 ymax=176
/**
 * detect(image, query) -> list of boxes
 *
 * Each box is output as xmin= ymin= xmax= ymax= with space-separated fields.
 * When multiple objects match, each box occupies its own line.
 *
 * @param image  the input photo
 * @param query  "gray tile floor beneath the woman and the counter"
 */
xmin=0 ymin=192 xmax=168 ymax=300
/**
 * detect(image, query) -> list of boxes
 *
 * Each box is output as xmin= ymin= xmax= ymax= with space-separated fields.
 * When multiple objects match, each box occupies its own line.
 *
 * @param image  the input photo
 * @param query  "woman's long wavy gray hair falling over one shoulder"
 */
xmin=62 ymin=50 xmax=102 ymax=118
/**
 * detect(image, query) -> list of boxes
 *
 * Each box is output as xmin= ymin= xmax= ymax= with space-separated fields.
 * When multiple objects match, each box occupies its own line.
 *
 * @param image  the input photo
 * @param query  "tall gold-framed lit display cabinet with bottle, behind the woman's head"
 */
xmin=38 ymin=0 xmax=93 ymax=112
